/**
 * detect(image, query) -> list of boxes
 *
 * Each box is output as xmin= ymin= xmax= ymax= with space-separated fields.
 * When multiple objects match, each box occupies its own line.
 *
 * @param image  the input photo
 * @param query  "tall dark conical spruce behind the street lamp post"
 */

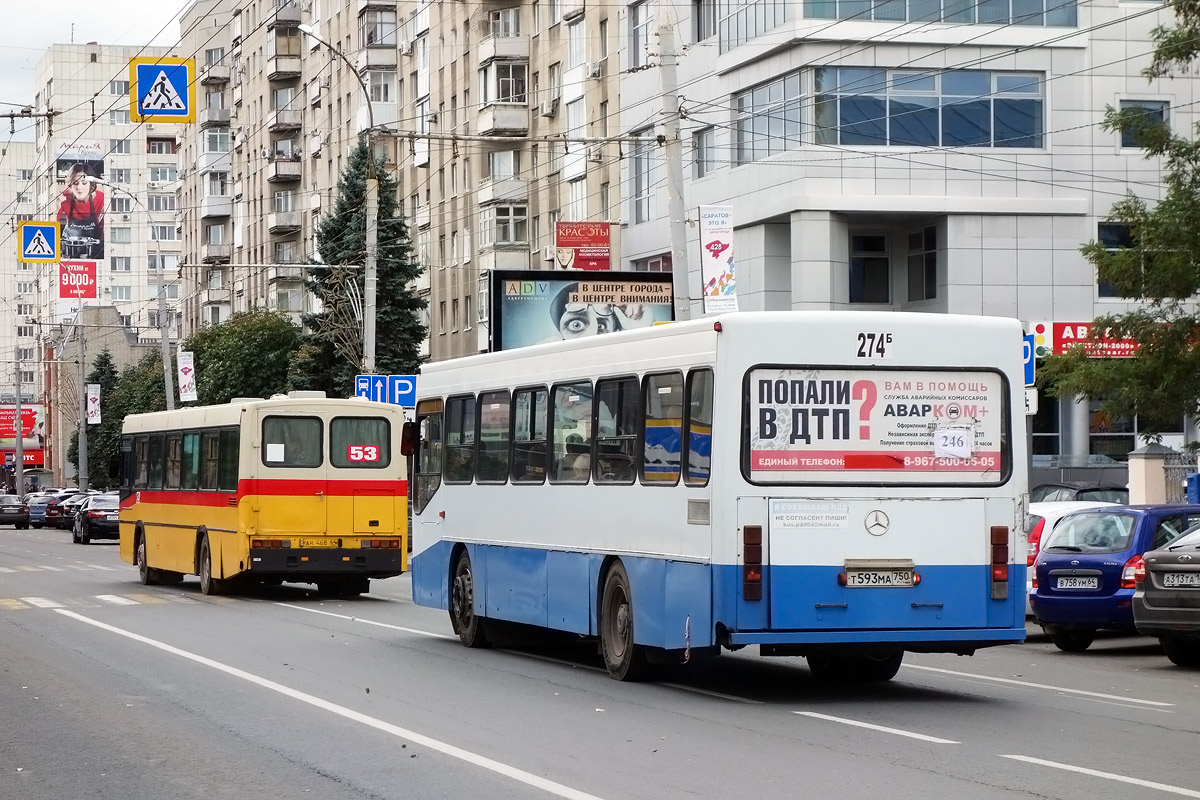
xmin=289 ymin=142 xmax=426 ymax=397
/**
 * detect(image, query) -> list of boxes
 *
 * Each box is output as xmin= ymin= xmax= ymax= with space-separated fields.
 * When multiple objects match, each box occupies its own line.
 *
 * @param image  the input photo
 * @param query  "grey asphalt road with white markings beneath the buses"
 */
xmin=0 ymin=528 xmax=1200 ymax=800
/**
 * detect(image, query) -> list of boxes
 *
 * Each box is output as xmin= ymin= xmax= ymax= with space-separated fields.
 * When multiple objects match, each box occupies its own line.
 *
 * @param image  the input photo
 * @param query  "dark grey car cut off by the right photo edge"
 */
xmin=1133 ymin=524 xmax=1200 ymax=667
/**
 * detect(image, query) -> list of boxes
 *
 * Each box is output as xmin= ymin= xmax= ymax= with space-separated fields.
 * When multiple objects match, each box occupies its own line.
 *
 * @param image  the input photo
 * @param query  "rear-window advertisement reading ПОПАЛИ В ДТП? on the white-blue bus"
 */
xmin=745 ymin=367 xmax=1010 ymax=485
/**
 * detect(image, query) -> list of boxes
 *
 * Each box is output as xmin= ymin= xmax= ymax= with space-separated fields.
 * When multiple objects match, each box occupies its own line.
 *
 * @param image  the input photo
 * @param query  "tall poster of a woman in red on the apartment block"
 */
xmin=54 ymin=142 xmax=106 ymax=261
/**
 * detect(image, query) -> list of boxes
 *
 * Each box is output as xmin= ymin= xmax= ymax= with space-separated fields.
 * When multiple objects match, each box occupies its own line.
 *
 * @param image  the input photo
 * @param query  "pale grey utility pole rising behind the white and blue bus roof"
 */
xmin=659 ymin=4 xmax=691 ymax=320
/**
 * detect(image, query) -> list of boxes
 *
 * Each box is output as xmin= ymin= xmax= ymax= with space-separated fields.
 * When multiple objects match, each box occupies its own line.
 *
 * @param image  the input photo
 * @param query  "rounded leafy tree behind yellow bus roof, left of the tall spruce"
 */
xmin=184 ymin=311 xmax=302 ymax=405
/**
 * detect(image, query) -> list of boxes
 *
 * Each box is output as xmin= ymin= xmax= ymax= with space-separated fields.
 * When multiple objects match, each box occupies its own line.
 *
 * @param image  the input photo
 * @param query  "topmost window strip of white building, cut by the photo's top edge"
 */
xmin=804 ymin=0 xmax=1075 ymax=28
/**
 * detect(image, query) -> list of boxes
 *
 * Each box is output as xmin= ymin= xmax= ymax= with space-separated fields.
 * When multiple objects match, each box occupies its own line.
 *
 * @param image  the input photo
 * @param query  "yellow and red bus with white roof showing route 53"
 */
xmin=120 ymin=392 xmax=408 ymax=595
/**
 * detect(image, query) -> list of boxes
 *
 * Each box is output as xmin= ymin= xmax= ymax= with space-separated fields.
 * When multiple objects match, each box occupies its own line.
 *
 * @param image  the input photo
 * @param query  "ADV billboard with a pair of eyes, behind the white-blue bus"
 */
xmin=492 ymin=270 xmax=674 ymax=350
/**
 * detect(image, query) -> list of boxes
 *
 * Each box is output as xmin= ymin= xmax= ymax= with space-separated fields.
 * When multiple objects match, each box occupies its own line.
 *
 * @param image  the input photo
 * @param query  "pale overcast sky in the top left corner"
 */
xmin=0 ymin=0 xmax=187 ymax=140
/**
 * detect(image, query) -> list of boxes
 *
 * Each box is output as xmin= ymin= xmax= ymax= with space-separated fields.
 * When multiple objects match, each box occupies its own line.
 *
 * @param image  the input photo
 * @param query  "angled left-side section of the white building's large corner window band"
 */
xmin=733 ymin=72 xmax=800 ymax=164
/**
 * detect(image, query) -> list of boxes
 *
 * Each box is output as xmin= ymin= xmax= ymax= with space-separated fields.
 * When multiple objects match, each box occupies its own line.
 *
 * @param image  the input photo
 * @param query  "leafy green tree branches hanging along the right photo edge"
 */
xmin=1043 ymin=0 xmax=1200 ymax=440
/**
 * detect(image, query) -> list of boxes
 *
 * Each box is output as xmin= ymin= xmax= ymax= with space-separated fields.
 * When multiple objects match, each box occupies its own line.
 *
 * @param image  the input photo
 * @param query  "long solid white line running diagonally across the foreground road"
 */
xmin=56 ymin=608 xmax=601 ymax=800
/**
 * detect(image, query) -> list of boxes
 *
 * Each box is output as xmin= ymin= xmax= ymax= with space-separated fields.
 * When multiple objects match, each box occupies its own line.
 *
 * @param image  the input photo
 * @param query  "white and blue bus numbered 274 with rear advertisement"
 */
xmin=412 ymin=312 xmax=1027 ymax=680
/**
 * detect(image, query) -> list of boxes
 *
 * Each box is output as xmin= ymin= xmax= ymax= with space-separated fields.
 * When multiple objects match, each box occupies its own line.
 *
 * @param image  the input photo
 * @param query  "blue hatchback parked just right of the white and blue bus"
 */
xmin=1030 ymin=505 xmax=1200 ymax=652
